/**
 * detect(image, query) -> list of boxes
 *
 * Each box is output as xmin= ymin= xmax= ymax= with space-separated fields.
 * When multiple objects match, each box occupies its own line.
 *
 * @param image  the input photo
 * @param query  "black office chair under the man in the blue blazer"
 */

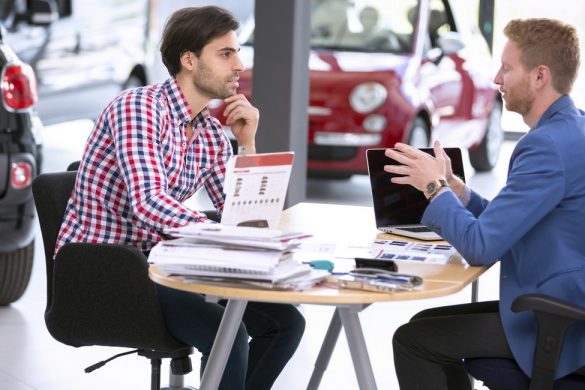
xmin=464 ymin=294 xmax=585 ymax=390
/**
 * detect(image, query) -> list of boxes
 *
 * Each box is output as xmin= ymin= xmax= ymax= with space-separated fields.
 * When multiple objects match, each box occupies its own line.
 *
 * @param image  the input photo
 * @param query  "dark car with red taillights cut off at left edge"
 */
xmin=0 ymin=1 xmax=66 ymax=306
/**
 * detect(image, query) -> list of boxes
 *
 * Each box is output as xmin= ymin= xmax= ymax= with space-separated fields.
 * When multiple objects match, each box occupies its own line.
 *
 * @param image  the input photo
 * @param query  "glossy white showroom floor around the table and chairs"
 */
xmin=0 ymin=121 xmax=513 ymax=390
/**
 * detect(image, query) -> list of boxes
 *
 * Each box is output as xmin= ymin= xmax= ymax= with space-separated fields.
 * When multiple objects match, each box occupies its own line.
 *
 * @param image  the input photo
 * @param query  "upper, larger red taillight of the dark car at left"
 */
xmin=2 ymin=64 xmax=37 ymax=111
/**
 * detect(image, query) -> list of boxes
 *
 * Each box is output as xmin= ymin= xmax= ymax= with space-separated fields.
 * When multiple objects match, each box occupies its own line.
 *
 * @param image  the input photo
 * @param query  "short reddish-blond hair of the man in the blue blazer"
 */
xmin=504 ymin=18 xmax=580 ymax=94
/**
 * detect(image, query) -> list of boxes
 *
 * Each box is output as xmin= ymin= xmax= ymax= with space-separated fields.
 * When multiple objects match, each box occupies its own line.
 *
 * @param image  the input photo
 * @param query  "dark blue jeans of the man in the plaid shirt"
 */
xmin=156 ymin=285 xmax=305 ymax=390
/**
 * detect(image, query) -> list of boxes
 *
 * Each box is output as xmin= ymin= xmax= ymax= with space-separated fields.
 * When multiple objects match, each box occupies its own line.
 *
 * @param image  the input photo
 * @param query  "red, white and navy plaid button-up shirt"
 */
xmin=55 ymin=78 xmax=233 ymax=253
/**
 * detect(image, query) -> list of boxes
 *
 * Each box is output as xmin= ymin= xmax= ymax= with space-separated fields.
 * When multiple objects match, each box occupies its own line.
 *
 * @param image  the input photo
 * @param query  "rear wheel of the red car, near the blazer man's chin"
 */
xmin=469 ymin=100 xmax=504 ymax=172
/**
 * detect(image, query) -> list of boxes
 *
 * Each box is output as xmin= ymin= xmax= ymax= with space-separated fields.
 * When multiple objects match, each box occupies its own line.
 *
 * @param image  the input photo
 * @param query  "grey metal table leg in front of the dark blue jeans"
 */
xmin=199 ymin=299 xmax=248 ymax=390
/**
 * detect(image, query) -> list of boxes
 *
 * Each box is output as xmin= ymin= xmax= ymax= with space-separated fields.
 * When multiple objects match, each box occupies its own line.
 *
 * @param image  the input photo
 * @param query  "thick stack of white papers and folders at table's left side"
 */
xmin=148 ymin=224 xmax=320 ymax=284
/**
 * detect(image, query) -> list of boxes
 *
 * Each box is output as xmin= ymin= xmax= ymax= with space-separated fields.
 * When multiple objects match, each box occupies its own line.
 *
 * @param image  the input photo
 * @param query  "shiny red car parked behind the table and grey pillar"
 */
xmin=208 ymin=0 xmax=503 ymax=177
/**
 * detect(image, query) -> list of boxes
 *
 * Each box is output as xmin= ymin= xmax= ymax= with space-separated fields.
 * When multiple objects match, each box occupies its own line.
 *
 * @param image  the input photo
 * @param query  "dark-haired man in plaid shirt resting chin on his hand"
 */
xmin=55 ymin=7 xmax=305 ymax=390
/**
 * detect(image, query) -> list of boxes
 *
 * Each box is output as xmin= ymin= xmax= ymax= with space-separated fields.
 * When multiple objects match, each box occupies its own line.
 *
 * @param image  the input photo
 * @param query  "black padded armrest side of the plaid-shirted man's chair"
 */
xmin=45 ymin=243 xmax=184 ymax=351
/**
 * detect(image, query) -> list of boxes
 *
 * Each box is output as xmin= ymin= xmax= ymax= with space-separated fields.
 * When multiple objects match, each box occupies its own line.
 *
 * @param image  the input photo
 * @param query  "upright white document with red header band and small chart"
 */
xmin=221 ymin=152 xmax=294 ymax=229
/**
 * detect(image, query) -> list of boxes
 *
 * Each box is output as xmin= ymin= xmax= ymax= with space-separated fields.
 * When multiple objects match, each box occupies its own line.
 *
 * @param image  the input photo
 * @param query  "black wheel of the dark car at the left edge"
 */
xmin=0 ymin=241 xmax=34 ymax=306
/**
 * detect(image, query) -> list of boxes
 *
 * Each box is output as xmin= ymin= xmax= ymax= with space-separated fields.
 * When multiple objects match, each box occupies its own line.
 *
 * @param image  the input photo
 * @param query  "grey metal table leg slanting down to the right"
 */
xmin=337 ymin=306 xmax=377 ymax=390
